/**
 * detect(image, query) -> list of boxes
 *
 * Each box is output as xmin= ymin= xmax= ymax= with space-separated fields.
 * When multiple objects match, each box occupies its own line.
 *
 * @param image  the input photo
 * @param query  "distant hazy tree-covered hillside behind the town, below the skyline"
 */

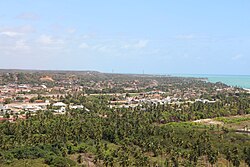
xmin=0 ymin=70 xmax=219 ymax=94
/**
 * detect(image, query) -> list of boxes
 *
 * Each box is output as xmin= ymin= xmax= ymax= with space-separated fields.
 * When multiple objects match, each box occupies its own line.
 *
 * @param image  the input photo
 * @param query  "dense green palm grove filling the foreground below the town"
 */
xmin=0 ymin=96 xmax=250 ymax=166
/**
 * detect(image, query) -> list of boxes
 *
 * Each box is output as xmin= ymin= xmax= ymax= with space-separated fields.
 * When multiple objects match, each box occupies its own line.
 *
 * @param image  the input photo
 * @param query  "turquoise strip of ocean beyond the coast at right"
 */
xmin=173 ymin=74 xmax=250 ymax=89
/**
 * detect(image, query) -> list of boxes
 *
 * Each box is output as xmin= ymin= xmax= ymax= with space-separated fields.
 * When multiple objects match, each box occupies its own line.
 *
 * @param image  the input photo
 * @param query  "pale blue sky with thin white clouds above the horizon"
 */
xmin=0 ymin=0 xmax=250 ymax=75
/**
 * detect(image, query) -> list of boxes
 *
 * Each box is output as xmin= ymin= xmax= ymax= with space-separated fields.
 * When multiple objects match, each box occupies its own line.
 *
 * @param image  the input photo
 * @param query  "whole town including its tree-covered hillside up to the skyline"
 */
xmin=0 ymin=71 xmax=246 ymax=121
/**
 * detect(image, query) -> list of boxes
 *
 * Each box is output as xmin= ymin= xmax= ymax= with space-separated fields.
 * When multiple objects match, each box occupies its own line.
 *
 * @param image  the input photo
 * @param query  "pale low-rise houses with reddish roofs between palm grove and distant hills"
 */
xmin=0 ymin=77 xmax=245 ymax=120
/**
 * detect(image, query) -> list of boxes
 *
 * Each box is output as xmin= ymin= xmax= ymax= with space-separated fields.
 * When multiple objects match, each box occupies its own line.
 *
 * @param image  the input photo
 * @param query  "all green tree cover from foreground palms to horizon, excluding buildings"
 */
xmin=0 ymin=71 xmax=250 ymax=167
